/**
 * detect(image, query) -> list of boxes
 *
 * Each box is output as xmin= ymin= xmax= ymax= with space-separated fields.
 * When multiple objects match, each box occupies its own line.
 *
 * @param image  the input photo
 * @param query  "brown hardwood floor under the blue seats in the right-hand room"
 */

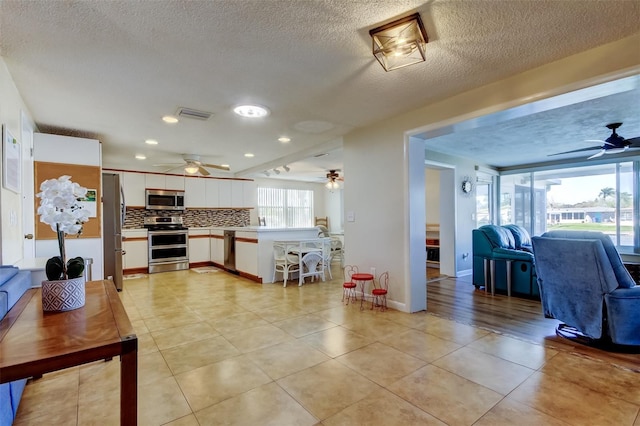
xmin=427 ymin=276 xmax=640 ymax=372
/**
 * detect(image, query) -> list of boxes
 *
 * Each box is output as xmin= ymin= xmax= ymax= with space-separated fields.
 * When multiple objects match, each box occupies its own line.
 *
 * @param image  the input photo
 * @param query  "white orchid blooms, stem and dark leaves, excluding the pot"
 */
xmin=36 ymin=175 xmax=89 ymax=280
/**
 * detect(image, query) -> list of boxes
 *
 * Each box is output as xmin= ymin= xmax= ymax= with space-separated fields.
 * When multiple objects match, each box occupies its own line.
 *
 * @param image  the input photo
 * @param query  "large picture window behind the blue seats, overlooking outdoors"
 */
xmin=500 ymin=161 xmax=640 ymax=251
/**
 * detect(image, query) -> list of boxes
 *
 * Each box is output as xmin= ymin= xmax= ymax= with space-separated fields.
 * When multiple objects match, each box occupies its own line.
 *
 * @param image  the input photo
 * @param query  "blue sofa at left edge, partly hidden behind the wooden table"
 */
xmin=0 ymin=266 xmax=31 ymax=425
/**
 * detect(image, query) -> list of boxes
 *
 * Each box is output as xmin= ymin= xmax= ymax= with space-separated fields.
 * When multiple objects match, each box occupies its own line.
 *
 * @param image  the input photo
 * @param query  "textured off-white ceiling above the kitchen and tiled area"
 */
xmin=0 ymin=0 xmax=640 ymax=178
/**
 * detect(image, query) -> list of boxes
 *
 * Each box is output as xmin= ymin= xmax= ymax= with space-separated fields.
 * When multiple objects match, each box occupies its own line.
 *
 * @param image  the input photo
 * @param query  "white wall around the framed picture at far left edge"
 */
xmin=0 ymin=57 xmax=33 ymax=265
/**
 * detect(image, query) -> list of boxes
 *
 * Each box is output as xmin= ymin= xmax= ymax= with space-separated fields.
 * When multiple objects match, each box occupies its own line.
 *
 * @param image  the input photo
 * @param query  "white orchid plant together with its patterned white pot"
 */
xmin=36 ymin=175 xmax=89 ymax=311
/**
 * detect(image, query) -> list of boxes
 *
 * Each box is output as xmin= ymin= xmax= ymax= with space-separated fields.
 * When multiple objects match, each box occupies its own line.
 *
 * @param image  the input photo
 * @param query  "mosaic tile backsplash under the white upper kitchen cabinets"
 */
xmin=124 ymin=207 xmax=250 ymax=229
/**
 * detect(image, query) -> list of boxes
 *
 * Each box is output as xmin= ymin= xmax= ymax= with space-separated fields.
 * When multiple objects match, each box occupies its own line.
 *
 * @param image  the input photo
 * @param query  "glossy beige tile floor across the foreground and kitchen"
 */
xmin=15 ymin=270 xmax=640 ymax=426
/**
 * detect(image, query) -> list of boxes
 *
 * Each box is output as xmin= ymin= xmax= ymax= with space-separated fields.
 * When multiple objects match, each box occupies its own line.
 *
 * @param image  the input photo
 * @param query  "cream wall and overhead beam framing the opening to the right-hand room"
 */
xmin=343 ymin=34 xmax=640 ymax=311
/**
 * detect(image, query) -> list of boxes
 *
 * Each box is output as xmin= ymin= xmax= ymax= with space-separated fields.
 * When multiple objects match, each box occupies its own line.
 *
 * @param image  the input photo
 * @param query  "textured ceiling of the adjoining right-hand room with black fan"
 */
xmin=416 ymin=75 xmax=640 ymax=169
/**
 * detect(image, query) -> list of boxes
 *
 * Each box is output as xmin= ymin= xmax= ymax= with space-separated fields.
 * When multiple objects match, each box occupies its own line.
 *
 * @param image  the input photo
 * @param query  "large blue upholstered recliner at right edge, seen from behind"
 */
xmin=532 ymin=231 xmax=640 ymax=346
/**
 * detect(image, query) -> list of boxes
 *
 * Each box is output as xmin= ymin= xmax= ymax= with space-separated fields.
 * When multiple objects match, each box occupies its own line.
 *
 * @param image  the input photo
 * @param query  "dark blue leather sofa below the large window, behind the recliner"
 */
xmin=472 ymin=225 xmax=540 ymax=299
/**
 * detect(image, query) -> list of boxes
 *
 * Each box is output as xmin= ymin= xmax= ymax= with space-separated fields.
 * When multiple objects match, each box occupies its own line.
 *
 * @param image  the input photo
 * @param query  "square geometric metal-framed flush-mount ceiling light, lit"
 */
xmin=369 ymin=13 xmax=429 ymax=71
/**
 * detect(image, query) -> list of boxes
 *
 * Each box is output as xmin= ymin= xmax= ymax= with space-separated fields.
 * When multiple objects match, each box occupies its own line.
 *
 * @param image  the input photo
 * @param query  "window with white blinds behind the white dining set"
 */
xmin=258 ymin=188 xmax=313 ymax=228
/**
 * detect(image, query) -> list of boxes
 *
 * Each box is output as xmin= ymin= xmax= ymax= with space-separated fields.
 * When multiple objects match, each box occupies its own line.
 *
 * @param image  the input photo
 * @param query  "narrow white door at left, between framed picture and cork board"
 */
xmin=20 ymin=111 xmax=36 ymax=259
